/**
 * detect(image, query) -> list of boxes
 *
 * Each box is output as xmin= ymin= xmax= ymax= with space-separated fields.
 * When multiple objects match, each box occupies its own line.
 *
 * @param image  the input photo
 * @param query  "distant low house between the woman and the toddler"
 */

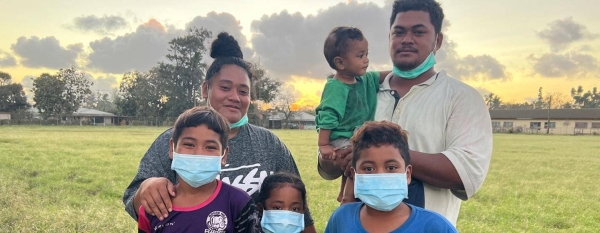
xmin=268 ymin=112 xmax=316 ymax=129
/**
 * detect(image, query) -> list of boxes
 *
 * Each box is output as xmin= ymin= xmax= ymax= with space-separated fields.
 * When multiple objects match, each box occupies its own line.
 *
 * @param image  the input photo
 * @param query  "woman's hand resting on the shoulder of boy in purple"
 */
xmin=134 ymin=177 xmax=175 ymax=221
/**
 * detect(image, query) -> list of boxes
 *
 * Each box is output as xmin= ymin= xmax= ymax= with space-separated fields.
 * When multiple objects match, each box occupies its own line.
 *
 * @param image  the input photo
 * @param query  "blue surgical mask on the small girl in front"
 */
xmin=260 ymin=210 xmax=304 ymax=233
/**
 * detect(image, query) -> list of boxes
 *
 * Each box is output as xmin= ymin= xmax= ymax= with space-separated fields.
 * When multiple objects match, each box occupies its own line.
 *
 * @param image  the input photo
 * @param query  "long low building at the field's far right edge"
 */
xmin=490 ymin=109 xmax=600 ymax=135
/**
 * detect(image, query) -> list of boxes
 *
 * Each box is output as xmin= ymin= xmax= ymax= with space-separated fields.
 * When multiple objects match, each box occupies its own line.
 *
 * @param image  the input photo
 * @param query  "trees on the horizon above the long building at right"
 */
xmin=483 ymin=86 xmax=600 ymax=110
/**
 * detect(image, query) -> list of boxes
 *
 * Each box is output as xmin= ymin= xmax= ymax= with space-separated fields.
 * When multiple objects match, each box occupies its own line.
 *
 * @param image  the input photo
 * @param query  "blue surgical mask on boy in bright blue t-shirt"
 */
xmin=354 ymin=173 xmax=408 ymax=212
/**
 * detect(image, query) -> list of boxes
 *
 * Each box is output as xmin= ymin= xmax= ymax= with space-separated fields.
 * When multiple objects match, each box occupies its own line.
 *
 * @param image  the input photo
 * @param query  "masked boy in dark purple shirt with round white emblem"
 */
xmin=138 ymin=107 xmax=260 ymax=233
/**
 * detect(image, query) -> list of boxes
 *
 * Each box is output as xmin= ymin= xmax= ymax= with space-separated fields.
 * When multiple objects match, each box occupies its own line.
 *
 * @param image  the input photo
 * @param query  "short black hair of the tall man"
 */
xmin=390 ymin=0 xmax=444 ymax=34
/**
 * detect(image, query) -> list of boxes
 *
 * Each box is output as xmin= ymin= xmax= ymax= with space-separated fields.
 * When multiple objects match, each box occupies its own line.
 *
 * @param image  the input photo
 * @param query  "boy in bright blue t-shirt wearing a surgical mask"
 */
xmin=325 ymin=121 xmax=457 ymax=233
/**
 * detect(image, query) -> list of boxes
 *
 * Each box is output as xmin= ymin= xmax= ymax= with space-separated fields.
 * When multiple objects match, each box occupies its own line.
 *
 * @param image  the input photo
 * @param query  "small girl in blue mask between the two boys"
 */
xmin=257 ymin=173 xmax=307 ymax=233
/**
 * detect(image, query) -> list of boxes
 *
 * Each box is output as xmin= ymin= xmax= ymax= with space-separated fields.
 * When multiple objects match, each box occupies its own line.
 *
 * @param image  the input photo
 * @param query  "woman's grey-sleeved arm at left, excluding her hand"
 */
xmin=123 ymin=129 xmax=175 ymax=219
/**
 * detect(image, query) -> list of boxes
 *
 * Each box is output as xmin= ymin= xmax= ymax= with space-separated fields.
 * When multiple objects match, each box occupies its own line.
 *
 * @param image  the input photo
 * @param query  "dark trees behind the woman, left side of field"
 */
xmin=0 ymin=28 xmax=282 ymax=124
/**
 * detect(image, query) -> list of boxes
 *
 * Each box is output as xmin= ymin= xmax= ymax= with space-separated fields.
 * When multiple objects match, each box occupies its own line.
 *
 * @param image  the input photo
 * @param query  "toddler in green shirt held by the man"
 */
xmin=315 ymin=26 xmax=390 ymax=204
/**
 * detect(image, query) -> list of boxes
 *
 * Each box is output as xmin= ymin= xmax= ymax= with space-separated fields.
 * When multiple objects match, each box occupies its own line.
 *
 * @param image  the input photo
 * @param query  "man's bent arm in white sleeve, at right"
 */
xmin=410 ymin=88 xmax=492 ymax=200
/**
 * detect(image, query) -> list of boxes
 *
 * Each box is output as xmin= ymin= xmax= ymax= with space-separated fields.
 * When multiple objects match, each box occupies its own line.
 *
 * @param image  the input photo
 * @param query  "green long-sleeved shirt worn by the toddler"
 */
xmin=315 ymin=71 xmax=379 ymax=140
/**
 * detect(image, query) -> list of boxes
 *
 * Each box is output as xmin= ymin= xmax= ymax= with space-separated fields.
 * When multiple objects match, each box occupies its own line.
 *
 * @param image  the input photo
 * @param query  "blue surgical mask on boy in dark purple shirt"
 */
xmin=171 ymin=149 xmax=223 ymax=188
